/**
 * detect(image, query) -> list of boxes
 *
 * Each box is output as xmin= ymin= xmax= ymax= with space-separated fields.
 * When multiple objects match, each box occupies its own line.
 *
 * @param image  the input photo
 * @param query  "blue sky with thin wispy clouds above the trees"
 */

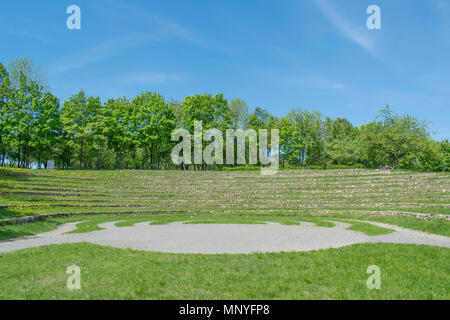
xmin=0 ymin=0 xmax=450 ymax=139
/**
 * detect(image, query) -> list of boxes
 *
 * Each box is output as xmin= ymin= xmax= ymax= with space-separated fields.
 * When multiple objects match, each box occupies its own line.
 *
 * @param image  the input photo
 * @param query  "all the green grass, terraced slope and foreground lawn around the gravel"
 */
xmin=0 ymin=168 xmax=450 ymax=299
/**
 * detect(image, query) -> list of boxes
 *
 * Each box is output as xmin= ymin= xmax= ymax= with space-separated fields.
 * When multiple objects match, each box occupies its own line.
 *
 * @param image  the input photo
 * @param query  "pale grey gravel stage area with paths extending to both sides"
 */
xmin=0 ymin=221 xmax=450 ymax=254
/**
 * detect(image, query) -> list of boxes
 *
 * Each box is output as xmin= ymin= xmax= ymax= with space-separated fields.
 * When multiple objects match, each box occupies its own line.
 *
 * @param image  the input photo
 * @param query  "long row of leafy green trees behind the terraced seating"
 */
xmin=0 ymin=59 xmax=450 ymax=171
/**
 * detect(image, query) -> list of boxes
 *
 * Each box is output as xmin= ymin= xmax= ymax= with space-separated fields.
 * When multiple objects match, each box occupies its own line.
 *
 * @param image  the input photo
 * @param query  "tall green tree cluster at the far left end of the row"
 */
xmin=0 ymin=59 xmax=60 ymax=167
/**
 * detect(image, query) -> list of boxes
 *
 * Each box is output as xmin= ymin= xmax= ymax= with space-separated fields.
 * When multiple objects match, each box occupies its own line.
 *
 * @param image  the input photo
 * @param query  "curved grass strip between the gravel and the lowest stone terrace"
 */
xmin=0 ymin=212 xmax=450 ymax=240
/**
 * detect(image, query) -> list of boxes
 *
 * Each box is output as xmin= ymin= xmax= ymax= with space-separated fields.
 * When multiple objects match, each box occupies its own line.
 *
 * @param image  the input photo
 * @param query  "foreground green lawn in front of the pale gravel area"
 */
xmin=0 ymin=243 xmax=450 ymax=299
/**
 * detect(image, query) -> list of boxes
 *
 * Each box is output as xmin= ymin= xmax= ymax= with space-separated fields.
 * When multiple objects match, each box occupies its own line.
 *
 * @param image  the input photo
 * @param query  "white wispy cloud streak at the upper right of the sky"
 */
xmin=315 ymin=0 xmax=376 ymax=56
